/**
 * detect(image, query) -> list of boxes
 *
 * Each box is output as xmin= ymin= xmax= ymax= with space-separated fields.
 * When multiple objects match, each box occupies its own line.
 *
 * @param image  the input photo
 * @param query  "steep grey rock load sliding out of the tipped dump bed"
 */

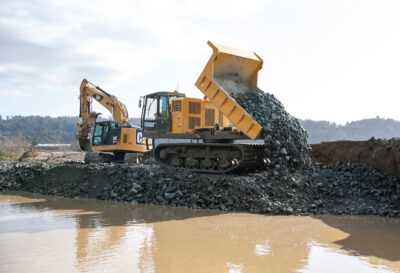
xmin=233 ymin=90 xmax=311 ymax=169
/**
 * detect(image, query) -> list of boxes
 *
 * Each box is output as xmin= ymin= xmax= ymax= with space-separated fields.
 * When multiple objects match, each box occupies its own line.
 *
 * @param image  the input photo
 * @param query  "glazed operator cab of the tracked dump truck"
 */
xmin=139 ymin=92 xmax=185 ymax=134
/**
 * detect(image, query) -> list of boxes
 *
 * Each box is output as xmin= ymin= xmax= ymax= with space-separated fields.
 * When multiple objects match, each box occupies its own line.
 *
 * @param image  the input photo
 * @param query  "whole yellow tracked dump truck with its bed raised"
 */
xmin=139 ymin=41 xmax=267 ymax=173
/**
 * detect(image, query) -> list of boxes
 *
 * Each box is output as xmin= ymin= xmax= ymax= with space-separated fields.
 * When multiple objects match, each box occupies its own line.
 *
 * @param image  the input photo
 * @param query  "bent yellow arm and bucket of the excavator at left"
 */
xmin=76 ymin=79 xmax=129 ymax=151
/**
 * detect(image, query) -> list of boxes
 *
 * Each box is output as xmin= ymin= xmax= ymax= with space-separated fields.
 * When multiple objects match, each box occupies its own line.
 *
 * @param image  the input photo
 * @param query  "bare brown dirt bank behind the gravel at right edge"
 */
xmin=310 ymin=138 xmax=400 ymax=179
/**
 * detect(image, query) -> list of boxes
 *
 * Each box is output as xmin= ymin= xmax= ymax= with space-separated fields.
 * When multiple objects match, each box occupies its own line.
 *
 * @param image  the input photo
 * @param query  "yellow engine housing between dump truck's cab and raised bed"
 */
xmin=169 ymin=97 xmax=229 ymax=134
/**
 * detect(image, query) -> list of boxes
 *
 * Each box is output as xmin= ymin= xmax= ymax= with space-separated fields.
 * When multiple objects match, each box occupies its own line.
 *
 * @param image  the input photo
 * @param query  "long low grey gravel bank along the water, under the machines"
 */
xmin=0 ymin=162 xmax=400 ymax=217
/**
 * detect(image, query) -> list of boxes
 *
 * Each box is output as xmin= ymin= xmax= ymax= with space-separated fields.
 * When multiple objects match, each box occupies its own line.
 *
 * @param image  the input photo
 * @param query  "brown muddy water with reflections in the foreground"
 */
xmin=0 ymin=193 xmax=400 ymax=272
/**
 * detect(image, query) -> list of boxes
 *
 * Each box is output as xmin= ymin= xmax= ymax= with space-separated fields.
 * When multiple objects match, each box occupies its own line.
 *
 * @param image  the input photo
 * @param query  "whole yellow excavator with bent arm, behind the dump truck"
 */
xmin=76 ymin=79 xmax=152 ymax=163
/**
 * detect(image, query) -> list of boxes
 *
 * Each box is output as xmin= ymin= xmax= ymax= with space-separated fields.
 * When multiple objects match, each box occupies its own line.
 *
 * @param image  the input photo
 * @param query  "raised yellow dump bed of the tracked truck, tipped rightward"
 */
xmin=196 ymin=41 xmax=263 ymax=139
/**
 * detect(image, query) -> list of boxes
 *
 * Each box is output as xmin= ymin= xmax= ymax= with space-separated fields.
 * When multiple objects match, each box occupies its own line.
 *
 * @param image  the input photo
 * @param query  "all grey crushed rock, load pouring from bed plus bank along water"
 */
xmin=0 ymin=83 xmax=400 ymax=217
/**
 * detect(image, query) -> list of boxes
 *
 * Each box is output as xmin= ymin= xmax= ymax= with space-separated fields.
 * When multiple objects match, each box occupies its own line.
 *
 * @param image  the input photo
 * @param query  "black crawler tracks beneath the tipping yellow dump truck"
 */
xmin=154 ymin=143 xmax=265 ymax=174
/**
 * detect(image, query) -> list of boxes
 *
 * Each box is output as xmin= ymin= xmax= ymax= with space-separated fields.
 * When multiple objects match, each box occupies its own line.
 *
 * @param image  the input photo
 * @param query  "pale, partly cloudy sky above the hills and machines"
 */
xmin=0 ymin=0 xmax=400 ymax=124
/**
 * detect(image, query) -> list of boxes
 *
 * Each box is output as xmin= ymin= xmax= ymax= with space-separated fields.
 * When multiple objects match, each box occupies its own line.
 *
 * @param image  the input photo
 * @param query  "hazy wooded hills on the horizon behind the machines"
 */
xmin=0 ymin=116 xmax=400 ymax=143
